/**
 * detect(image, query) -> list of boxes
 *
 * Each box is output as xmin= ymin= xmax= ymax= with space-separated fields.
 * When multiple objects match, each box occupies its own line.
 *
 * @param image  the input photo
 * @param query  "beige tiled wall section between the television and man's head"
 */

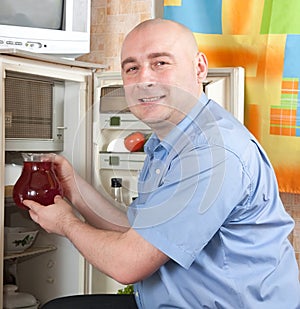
xmin=77 ymin=0 xmax=154 ymax=71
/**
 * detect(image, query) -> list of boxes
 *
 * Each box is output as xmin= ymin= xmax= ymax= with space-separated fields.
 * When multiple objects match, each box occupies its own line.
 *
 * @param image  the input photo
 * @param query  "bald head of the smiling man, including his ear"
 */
xmin=121 ymin=19 xmax=207 ymax=136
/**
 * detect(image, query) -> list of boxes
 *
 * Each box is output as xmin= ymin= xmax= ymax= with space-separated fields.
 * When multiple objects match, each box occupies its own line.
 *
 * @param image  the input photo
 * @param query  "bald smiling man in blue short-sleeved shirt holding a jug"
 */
xmin=24 ymin=19 xmax=300 ymax=309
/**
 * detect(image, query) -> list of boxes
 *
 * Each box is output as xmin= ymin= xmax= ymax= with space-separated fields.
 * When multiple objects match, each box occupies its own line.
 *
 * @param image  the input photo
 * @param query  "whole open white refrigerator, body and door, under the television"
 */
xmin=0 ymin=50 xmax=244 ymax=307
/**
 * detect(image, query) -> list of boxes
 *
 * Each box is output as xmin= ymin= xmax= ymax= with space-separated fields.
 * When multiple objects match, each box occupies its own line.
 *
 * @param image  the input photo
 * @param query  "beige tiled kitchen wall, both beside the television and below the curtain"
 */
xmin=78 ymin=0 xmax=300 ymax=266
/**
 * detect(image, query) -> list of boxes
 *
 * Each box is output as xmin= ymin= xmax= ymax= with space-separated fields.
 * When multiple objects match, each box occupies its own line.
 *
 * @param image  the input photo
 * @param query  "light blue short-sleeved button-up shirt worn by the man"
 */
xmin=128 ymin=94 xmax=300 ymax=309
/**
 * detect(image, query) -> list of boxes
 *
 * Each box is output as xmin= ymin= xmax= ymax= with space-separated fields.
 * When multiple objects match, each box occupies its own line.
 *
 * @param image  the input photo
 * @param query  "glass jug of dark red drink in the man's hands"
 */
xmin=13 ymin=153 xmax=63 ymax=209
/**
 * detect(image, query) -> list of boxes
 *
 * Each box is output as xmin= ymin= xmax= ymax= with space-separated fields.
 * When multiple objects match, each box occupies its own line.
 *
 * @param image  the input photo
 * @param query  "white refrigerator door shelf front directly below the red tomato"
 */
xmin=99 ymin=152 xmax=146 ymax=171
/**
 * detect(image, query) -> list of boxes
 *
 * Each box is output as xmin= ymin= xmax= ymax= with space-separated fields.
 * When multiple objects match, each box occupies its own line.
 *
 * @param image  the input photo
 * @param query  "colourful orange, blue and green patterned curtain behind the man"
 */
xmin=164 ymin=0 xmax=300 ymax=193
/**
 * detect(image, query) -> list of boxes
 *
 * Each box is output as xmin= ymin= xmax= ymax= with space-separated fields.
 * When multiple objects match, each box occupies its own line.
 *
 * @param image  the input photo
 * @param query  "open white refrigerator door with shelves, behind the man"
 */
xmin=89 ymin=67 xmax=244 ymax=293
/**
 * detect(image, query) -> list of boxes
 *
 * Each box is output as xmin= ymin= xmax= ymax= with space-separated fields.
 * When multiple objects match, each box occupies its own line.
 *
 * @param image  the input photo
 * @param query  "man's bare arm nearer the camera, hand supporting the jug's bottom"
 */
xmin=24 ymin=197 xmax=169 ymax=284
